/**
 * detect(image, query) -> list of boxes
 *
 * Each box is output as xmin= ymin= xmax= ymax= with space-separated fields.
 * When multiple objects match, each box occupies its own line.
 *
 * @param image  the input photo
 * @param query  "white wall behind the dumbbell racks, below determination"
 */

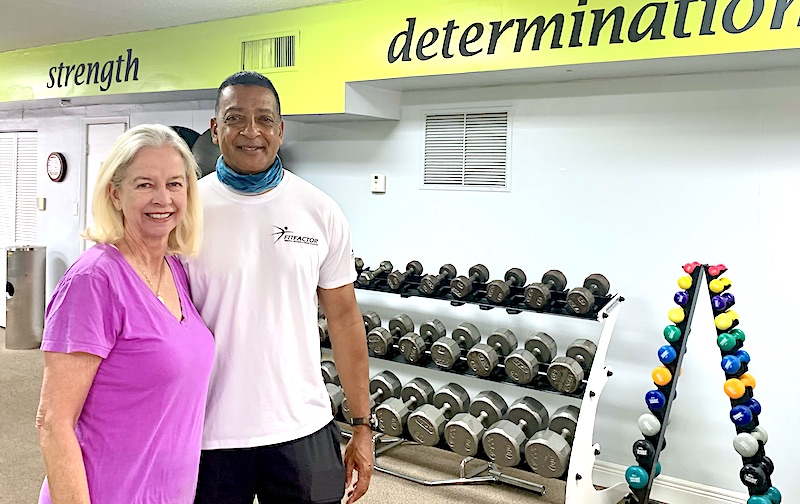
xmin=284 ymin=70 xmax=800 ymax=502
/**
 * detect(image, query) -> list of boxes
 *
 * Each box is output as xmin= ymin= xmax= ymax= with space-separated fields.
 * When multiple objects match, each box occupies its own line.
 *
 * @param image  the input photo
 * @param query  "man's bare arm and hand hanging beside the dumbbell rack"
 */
xmin=317 ymin=284 xmax=373 ymax=503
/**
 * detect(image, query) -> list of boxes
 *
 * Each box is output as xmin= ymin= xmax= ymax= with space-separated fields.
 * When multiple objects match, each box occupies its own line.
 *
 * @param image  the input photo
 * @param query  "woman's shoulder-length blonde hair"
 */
xmin=81 ymin=124 xmax=203 ymax=256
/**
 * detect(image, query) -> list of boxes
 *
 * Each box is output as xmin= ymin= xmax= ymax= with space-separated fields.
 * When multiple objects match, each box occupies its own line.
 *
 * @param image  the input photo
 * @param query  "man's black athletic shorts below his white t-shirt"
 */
xmin=194 ymin=421 xmax=345 ymax=504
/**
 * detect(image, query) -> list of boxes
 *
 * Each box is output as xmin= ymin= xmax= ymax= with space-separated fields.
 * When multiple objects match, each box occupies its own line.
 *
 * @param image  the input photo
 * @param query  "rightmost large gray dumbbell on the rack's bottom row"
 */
xmin=525 ymin=405 xmax=581 ymax=478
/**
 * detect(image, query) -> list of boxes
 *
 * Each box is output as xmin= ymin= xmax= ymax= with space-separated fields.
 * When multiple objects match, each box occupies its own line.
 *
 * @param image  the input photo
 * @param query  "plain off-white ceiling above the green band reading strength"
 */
xmin=0 ymin=0 xmax=342 ymax=52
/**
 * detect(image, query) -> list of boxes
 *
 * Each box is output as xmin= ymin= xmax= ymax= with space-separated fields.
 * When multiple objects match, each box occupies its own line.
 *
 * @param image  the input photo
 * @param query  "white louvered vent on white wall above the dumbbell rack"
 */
xmin=422 ymin=111 xmax=509 ymax=190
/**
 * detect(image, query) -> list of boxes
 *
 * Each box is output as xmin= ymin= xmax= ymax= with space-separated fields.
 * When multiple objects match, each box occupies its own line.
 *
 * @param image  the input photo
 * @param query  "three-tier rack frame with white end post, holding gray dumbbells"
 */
xmin=355 ymin=270 xmax=628 ymax=504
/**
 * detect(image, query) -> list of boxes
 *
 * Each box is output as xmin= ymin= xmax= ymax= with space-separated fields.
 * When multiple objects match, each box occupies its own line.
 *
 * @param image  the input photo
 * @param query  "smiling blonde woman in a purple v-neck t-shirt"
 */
xmin=36 ymin=125 xmax=214 ymax=504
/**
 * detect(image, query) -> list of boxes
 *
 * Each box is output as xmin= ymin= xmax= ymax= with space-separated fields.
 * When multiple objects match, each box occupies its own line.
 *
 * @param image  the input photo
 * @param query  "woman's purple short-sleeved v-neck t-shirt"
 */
xmin=39 ymin=244 xmax=214 ymax=504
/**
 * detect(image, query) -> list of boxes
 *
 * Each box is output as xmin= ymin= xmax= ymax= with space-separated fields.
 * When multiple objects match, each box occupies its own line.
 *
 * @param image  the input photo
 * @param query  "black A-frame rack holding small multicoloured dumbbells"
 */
xmin=627 ymin=263 xmax=780 ymax=504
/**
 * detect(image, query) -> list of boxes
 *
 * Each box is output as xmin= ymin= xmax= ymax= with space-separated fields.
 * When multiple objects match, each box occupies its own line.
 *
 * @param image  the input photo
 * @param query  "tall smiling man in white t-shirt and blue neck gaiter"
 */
xmin=187 ymin=72 xmax=373 ymax=504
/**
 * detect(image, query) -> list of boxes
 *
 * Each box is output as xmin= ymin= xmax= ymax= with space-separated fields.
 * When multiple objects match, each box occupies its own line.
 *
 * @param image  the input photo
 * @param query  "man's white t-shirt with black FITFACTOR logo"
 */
xmin=186 ymin=171 xmax=356 ymax=450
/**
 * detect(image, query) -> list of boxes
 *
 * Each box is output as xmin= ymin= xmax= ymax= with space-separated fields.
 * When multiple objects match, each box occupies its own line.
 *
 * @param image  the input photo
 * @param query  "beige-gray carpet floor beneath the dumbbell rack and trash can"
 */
xmin=0 ymin=328 xmax=565 ymax=504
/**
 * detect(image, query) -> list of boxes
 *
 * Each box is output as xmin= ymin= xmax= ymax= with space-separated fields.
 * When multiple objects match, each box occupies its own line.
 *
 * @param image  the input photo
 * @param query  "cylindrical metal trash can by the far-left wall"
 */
xmin=6 ymin=245 xmax=47 ymax=350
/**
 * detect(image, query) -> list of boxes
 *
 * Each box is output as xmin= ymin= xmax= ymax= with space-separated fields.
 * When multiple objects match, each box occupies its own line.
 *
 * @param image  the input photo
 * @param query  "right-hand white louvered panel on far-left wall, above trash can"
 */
xmin=14 ymin=133 xmax=38 ymax=244
